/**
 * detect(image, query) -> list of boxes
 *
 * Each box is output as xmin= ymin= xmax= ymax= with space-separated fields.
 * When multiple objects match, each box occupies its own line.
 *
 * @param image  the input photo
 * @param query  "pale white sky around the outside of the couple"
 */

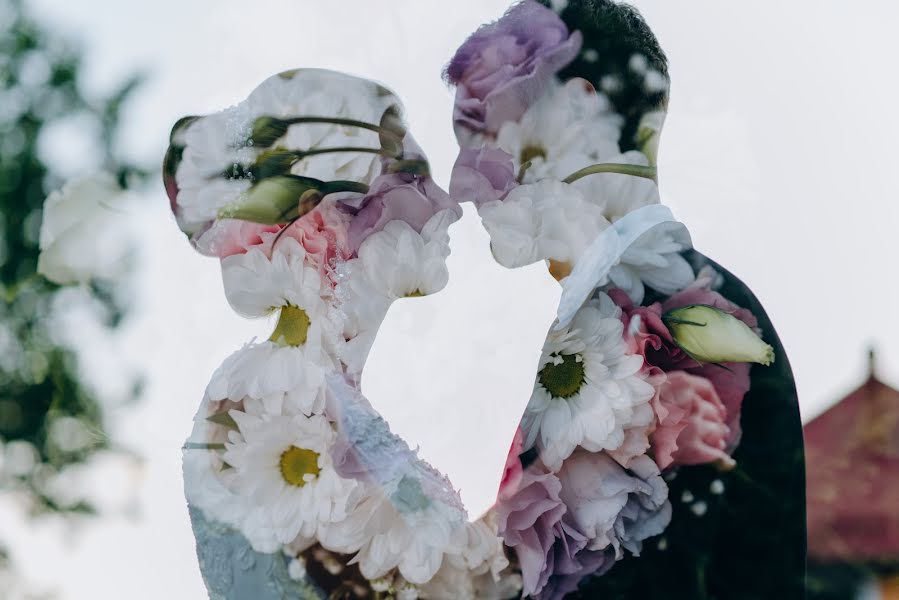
xmin=7 ymin=0 xmax=899 ymax=600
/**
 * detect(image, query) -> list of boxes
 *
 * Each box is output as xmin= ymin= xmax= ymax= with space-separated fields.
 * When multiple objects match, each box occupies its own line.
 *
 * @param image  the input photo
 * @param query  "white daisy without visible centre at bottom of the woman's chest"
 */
xmin=319 ymin=476 xmax=465 ymax=584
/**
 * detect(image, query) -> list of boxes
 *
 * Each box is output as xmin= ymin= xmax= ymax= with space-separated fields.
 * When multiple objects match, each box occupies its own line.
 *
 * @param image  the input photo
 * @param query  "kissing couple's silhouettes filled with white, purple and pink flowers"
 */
xmin=164 ymin=0 xmax=804 ymax=599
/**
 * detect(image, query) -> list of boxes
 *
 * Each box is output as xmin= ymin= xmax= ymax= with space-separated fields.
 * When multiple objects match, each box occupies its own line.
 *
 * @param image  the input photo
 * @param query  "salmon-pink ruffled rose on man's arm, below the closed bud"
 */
xmin=650 ymin=371 xmax=734 ymax=469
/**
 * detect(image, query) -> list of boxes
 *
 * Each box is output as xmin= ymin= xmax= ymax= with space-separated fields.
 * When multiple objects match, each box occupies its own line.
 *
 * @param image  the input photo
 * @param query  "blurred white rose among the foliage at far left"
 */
xmin=37 ymin=173 xmax=130 ymax=285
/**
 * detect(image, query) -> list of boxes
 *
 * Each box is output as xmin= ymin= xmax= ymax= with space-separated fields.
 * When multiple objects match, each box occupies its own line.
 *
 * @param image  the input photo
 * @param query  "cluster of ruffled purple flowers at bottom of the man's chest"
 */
xmin=497 ymin=451 xmax=671 ymax=600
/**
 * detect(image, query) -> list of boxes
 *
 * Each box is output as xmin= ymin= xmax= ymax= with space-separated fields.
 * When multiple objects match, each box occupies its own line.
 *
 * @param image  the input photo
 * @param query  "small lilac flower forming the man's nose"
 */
xmin=450 ymin=146 xmax=518 ymax=208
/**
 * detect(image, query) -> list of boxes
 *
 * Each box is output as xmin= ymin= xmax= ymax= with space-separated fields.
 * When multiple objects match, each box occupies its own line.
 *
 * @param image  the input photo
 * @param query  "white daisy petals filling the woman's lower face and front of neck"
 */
xmin=336 ymin=210 xmax=458 ymax=372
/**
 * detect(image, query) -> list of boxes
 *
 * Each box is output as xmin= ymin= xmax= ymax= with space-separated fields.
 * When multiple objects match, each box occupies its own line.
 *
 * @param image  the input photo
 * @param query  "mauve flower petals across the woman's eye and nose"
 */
xmin=341 ymin=173 xmax=462 ymax=252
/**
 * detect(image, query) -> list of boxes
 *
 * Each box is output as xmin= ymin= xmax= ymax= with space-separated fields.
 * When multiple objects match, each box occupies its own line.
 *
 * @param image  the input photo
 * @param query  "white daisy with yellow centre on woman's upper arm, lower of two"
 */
xmin=223 ymin=410 xmax=355 ymax=552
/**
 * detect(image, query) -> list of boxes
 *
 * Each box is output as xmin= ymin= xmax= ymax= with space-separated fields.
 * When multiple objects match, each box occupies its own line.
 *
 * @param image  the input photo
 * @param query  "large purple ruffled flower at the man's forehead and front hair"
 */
xmin=446 ymin=0 xmax=582 ymax=133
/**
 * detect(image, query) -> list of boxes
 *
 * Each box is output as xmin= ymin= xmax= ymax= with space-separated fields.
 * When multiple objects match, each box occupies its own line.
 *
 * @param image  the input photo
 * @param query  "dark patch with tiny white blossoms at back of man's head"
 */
xmin=539 ymin=0 xmax=669 ymax=152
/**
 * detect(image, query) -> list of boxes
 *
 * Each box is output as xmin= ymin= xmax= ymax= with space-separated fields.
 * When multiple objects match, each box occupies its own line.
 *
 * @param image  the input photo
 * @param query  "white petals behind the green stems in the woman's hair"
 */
xmin=176 ymin=69 xmax=399 ymax=233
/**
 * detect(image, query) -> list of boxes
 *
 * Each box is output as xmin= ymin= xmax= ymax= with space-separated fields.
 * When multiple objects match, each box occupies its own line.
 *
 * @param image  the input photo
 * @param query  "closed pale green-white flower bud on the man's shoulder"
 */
xmin=663 ymin=304 xmax=774 ymax=365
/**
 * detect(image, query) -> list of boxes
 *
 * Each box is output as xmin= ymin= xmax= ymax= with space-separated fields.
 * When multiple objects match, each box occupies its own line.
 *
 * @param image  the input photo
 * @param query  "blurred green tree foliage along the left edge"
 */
xmin=0 ymin=0 xmax=146 ymax=580
